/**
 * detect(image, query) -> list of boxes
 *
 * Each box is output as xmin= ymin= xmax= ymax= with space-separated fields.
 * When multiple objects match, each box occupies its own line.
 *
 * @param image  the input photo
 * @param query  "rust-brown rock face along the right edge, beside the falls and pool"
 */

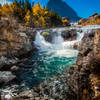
xmin=67 ymin=30 xmax=100 ymax=100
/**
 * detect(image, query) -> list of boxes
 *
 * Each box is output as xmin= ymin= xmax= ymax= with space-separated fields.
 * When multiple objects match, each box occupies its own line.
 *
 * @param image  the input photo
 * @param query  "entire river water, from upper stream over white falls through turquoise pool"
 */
xmin=21 ymin=25 xmax=100 ymax=86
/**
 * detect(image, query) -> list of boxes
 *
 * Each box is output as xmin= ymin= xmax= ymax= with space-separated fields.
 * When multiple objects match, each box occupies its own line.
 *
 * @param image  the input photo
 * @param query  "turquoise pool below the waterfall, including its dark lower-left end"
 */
xmin=20 ymin=52 xmax=76 ymax=86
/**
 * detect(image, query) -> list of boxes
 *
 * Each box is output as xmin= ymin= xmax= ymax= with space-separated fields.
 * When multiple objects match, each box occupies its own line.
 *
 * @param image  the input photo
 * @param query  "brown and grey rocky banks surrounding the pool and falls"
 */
xmin=0 ymin=20 xmax=100 ymax=100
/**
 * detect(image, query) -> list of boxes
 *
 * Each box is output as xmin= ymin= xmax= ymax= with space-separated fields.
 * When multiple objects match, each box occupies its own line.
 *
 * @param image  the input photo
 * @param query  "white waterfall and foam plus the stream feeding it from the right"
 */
xmin=34 ymin=25 xmax=100 ymax=57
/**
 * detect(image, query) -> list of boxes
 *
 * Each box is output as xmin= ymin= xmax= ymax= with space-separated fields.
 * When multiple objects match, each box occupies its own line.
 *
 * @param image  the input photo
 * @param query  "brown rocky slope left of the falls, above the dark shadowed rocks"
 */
xmin=0 ymin=20 xmax=36 ymax=57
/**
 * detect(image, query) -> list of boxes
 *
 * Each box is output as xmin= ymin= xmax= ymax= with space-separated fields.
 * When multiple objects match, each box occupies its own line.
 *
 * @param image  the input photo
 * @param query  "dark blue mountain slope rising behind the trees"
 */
xmin=47 ymin=0 xmax=80 ymax=21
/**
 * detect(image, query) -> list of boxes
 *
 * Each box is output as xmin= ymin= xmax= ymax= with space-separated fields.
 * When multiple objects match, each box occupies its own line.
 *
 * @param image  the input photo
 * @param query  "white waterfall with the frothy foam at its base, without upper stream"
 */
xmin=34 ymin=29 xmax=84 ymax=57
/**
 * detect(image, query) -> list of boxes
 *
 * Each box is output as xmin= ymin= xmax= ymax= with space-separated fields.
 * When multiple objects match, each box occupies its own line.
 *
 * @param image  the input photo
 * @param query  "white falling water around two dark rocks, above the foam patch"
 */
xmin=34 ymin=30 xmax=84 ymax=50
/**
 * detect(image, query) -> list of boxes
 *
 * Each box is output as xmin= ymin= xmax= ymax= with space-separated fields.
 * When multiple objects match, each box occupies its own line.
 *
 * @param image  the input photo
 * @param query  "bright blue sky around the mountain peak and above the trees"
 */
xmin=0 ymin=0 xmax=100 ymax=18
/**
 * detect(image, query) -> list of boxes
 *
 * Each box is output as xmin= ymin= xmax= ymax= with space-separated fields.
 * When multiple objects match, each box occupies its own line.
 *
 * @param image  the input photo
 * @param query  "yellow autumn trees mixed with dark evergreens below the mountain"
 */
xmin=0 ymin=0 xmax=69 ymax=28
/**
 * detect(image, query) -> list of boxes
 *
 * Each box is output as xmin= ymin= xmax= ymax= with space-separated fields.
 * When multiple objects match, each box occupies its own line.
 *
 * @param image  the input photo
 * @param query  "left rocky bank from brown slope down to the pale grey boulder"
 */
xmin=0 ymin=19 xmax=36 ymax=85
